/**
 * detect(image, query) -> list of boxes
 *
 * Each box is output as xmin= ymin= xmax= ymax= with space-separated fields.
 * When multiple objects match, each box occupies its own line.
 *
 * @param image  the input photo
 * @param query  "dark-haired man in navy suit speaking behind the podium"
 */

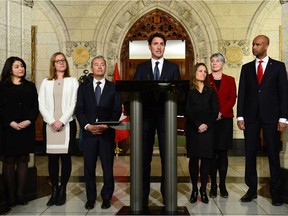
xmin=134 ymin=33 xmax=181 ymax=207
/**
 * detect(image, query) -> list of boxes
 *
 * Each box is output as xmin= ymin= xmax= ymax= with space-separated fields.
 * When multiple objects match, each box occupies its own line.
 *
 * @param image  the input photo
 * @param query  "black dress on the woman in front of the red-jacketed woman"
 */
xmin=185 ymin=87 xmax=219 ymax=158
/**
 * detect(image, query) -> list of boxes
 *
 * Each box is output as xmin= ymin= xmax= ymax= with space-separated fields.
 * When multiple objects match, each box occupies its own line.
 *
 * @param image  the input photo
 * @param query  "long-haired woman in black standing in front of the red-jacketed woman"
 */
xmin=185 ymin=63 xmax=218 ymax=203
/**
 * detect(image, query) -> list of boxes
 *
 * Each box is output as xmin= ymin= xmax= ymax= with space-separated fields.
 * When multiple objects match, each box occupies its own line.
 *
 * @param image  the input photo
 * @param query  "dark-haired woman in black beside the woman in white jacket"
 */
xmin=0 ymin=56 xmax=39 ymax=207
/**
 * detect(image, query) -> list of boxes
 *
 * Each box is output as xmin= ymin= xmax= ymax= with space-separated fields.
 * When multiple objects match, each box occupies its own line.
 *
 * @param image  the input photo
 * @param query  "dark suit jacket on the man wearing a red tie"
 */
xmin=237 ymin=58 xmax=288 ymax=123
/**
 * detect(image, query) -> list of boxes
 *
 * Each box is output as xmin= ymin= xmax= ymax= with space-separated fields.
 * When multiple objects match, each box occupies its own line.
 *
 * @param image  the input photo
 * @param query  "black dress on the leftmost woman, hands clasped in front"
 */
xmin=0 ymin=80 xmax=39 ymax=156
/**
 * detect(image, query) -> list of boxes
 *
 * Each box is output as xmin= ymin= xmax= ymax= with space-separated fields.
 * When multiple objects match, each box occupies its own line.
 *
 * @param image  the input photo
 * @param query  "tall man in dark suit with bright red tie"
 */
xmin=237 ymin=35 xmax=288 ymax=206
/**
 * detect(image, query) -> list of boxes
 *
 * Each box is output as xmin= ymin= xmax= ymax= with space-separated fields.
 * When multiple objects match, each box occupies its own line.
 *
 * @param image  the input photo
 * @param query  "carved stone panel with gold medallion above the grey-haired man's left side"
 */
xmin=66 ymin=41 xmax=96 ymax=69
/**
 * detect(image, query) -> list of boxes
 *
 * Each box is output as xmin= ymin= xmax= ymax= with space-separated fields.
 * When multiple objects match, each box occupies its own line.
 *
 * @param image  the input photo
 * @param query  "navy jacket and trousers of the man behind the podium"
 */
xmin=134 ymin=59 xmax=181 ymax=202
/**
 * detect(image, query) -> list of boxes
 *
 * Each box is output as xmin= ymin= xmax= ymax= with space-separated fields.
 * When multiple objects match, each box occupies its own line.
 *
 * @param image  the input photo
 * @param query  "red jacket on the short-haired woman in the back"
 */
xmin=209 ymin=74 xmax=237 ymax=118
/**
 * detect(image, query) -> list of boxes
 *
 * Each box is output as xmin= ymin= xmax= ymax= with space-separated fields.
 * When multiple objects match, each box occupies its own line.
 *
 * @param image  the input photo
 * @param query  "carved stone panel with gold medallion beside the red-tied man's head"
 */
xmin=219 ymin=40 xmax=249 ymax=67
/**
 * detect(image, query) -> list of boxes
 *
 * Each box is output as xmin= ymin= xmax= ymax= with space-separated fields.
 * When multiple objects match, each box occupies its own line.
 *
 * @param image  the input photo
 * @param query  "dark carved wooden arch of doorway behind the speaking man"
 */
xmin=120 ymin=9 xmax=195 ymax=80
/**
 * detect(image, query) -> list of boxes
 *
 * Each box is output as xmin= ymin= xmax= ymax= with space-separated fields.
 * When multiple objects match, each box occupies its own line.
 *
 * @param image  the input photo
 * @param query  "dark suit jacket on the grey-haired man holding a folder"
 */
xmin=76 ymin=77 xmax=122 ymax=142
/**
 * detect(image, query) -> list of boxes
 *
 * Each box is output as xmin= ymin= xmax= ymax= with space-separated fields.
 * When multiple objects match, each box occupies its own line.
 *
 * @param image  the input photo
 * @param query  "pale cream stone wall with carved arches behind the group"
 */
xmin=32 ymin=0 xmax=281 ymax=138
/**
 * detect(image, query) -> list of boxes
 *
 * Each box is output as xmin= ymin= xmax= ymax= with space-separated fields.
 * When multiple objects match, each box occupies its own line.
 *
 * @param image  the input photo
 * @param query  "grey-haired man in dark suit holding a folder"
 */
xmin=76 ymin=56 xmax=121 ymax=210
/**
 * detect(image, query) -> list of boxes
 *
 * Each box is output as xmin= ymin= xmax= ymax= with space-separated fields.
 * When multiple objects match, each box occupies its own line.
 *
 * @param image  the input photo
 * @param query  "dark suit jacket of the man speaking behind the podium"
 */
xmin=133 ymin=59 xmax=181 ymax=117
